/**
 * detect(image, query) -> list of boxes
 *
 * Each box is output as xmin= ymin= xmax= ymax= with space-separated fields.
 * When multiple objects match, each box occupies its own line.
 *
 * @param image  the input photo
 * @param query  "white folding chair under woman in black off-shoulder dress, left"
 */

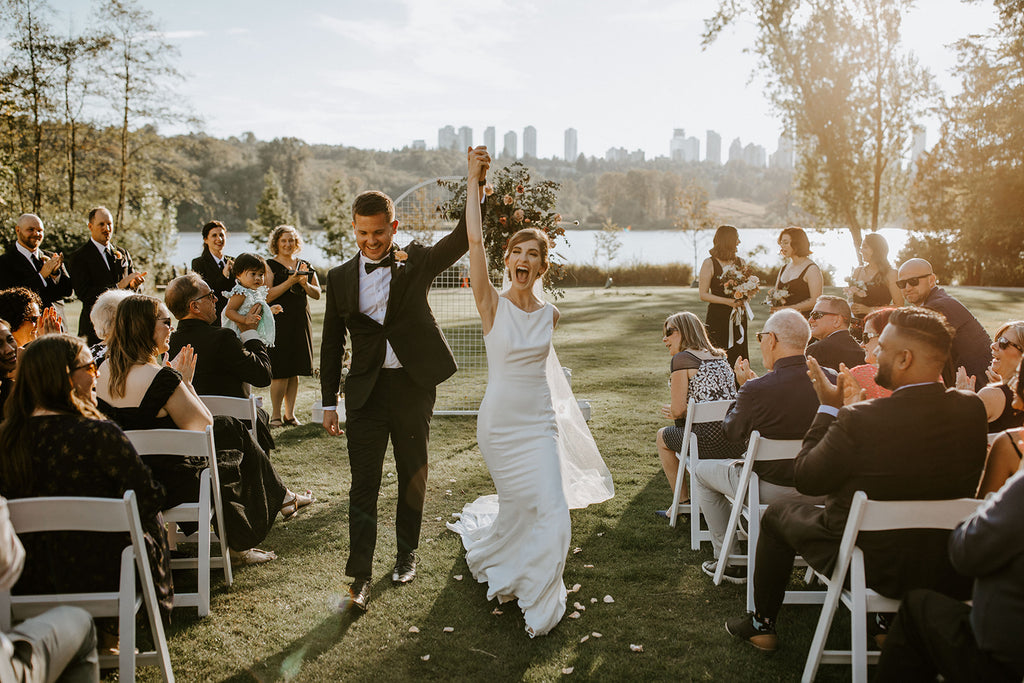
xmin=125 ymin=426 xmax=233 ymax=616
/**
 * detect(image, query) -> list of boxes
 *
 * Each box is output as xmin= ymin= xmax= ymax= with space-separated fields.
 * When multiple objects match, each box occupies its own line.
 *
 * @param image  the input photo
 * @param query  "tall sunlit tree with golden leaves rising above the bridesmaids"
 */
xmin=703 ymin=0 xmax=932 ymax=251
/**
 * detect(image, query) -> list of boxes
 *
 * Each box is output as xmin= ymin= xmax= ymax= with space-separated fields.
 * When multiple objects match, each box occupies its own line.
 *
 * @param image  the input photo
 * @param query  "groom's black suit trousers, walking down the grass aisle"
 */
xmin=345 ymin=369 xmax=436 ymax=580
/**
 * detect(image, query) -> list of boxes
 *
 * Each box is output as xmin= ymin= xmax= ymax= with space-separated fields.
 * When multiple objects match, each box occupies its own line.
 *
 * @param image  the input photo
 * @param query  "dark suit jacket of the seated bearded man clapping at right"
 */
xmin=783 ymin=383 xmax=988 ymax=597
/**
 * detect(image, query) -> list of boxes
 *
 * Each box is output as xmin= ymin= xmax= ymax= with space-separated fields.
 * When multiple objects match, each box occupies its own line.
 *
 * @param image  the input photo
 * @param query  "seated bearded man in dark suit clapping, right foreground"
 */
xmin=726 ymin=308 xmax=988 ymax=650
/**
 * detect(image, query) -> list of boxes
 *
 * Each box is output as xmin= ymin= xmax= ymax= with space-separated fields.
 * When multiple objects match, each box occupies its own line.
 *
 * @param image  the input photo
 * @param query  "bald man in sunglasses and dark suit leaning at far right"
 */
xmin=896 ymin=258 xmax=992 ymax=391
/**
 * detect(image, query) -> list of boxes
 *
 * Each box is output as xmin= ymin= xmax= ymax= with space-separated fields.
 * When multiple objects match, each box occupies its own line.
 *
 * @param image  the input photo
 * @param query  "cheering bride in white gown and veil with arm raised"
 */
xmin=449 ymin=148 xmax=613 ymax=637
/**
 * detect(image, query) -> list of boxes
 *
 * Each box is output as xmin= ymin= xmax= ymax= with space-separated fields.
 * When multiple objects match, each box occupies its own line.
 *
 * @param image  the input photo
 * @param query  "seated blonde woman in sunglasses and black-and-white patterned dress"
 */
xmin=656 ymin=311 xmax=743 ymax=517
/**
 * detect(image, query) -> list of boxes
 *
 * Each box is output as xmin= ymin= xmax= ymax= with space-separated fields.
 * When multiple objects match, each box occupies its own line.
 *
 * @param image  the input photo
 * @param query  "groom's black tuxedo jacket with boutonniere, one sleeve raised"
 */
xmin=321 ymin=215 xmax=469 ymax=409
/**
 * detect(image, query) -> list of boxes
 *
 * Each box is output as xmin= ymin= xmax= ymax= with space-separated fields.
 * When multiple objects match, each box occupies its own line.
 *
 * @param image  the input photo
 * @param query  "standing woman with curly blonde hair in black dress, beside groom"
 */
xmin=266 ymin=225 xmax=321 ymax=427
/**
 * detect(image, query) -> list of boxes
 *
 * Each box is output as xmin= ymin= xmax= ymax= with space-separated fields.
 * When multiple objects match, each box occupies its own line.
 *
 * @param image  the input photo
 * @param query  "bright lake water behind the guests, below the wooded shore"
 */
xmin=169 ymin=228 xmax=909 ymax=284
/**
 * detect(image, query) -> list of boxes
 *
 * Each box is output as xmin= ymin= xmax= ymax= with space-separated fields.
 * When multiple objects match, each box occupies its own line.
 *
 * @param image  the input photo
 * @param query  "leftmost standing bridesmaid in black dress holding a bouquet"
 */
xmin=699 ymin=225 xmax=750 ymax=368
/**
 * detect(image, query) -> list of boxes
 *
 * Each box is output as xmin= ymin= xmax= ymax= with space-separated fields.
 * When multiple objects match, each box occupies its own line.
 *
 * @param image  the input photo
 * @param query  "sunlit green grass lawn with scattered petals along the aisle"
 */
xmin=68 ymin=287 xmax=1024 ymax=681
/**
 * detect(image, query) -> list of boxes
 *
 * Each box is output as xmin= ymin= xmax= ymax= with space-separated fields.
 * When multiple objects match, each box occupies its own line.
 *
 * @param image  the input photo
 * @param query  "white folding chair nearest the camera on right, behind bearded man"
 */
xmin=802 ymin=490 xmax=982 ymax=683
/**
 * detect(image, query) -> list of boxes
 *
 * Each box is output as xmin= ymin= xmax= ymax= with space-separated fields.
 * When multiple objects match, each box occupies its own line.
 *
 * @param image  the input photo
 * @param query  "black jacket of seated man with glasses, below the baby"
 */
xmin=169 ymin=319 xmax=272 ymax=398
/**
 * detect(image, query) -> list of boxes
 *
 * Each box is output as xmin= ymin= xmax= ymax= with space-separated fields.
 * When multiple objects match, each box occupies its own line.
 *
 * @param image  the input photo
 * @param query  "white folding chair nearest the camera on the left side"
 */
xmin=0 ymin=490 xmax=174 ymax=683
